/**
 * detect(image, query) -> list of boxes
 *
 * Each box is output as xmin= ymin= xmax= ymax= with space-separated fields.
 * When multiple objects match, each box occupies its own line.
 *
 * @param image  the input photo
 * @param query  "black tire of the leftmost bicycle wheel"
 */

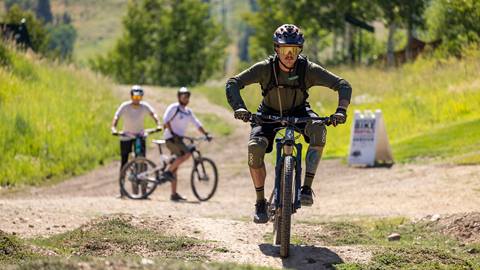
xmin=119 ymin=157 xmax=159 ymax=200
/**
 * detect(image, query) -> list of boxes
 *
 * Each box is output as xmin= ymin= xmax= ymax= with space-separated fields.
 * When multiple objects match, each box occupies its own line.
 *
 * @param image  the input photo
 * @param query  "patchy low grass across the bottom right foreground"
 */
xmin=297 ymin=217 xmax=480 ymax=270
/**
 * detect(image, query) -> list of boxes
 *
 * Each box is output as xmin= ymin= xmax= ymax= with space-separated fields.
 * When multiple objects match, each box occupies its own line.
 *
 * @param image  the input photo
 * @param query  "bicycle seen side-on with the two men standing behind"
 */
xmin=114 ymin=132 xmax=218 ymax=201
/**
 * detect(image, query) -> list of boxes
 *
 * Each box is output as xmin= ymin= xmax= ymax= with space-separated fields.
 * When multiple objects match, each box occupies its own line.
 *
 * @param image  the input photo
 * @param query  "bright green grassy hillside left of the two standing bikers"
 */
xmin=0 ymin=44 xmax=117 ymax=186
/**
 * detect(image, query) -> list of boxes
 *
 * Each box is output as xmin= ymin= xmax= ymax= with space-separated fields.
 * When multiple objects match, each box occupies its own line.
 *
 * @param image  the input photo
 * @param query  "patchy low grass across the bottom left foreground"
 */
xmin=0 ymin=215 xmax=278 ymax=270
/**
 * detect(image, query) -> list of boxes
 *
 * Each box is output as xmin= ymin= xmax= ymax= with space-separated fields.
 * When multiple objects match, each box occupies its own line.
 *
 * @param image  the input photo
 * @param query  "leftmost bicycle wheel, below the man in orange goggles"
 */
xmin=120 ymin=157 xmax=159 ymax=200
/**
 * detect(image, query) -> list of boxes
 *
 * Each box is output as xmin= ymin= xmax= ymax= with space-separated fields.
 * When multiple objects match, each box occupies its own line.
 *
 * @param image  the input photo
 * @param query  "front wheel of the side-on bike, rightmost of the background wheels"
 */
xmin=190 ymin=157 xmax=218 ymax=201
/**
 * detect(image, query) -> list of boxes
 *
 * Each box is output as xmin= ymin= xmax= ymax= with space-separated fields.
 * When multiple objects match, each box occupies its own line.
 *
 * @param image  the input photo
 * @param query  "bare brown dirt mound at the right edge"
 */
xmin=426 ymin=212 xmax=480 ymax=243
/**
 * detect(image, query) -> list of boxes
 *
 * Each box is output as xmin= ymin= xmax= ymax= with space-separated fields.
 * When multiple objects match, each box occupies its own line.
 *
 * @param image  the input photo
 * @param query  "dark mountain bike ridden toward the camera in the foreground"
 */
xmin=250 ymin=113 xmax=330 ymax=257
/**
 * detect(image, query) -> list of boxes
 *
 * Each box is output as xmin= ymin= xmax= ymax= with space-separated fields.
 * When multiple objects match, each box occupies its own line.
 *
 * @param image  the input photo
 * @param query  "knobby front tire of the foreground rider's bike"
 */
xmin=279 ymin=156 xmax=295 ymax=258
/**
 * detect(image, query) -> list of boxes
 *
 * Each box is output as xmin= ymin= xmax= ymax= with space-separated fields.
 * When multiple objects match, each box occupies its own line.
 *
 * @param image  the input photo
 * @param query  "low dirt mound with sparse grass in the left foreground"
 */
xmin=53 ymin=214 xmax=209 ymax=259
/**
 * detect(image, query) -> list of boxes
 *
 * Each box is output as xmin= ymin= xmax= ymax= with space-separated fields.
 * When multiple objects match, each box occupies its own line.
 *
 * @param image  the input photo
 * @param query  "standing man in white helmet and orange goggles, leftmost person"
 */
xmin=111 ymin=85 xmax=161 ymax=197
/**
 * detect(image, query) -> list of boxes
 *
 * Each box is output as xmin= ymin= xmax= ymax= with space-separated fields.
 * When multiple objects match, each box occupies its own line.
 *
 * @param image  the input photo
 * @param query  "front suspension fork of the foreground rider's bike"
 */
xmin=274 ymin=126 xmax=302 ymax=213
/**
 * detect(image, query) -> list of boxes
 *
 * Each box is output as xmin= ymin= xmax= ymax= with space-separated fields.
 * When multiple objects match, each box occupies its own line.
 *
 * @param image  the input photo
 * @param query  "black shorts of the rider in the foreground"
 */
xmin=250 ymin=109 xmax=318 ymax=153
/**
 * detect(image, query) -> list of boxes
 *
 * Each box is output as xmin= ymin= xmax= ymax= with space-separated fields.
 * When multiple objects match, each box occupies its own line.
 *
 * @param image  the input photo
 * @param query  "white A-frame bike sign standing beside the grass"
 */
xmin=348 ymin=110 xmax=393 ymax=166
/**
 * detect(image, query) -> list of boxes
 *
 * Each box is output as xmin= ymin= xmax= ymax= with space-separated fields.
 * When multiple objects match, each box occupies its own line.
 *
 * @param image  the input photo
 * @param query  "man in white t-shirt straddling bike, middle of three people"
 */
xmin=163 ymin=87 xmax=209 ymax=201
